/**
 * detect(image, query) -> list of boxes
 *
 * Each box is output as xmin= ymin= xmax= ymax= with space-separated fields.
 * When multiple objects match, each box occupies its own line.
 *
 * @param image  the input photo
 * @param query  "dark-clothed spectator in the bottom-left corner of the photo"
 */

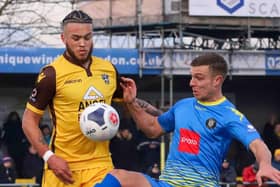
xmin=0 ymin=156 xmax=17 ymax=184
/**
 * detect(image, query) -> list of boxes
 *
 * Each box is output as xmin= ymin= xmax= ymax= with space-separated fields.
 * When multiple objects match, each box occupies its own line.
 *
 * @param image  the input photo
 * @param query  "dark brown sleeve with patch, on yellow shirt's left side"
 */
xmin=28 ymin=66 xmax=56 ymax=110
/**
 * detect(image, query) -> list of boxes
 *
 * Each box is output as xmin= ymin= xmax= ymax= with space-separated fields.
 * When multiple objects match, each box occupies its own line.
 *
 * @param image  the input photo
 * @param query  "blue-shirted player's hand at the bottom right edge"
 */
xmin=256 ymin=165 xmax=280 ymax=186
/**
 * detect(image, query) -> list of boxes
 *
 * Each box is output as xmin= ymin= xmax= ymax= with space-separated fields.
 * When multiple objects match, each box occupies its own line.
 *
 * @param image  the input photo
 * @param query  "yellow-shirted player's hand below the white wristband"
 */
xmin=48 ymin=155 xmax=74 ymax=184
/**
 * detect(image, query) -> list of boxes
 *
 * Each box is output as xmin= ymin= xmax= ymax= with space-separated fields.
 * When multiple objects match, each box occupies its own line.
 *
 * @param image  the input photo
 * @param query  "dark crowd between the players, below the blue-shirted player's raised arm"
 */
xmin=110 ymin=107 xmax=160 ymax=177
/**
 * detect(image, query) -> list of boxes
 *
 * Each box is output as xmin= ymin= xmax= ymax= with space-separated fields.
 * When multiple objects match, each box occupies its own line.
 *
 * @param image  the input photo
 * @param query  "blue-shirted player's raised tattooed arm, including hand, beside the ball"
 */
xmin=121 ymin=77 xmax=164 ymax=138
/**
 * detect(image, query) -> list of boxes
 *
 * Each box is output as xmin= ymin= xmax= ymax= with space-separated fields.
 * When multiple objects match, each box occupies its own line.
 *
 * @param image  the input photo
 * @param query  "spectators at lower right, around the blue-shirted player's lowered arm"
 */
xmin=221 ymin=114 xmax=280 ymax=187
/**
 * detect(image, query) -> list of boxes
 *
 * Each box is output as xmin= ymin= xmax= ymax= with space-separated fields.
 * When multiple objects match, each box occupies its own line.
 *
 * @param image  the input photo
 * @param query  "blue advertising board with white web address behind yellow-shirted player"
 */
xmin=0 ymin=48 xmax=163 ymax=75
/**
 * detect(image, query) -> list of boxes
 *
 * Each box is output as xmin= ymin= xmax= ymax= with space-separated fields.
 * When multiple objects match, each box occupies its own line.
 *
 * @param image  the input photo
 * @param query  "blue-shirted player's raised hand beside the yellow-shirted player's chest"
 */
xmin=120 ymin=77 xmax=137 ymax=103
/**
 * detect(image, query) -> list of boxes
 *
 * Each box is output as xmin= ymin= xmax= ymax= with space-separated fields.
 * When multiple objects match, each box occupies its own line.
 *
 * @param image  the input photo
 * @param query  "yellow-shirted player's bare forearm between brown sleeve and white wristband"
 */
xmin=22 ymin=109 xmax=49 ymax=156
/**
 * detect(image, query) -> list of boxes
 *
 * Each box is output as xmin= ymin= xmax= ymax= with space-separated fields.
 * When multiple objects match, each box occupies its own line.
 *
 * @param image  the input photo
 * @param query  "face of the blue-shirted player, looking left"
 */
xmin=190 ymin=65 xmax=218 ymax=101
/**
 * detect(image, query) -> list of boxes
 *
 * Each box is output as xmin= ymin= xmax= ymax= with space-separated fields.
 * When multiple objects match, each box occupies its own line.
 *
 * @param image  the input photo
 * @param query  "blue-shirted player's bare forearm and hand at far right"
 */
xmin=250 ymin=139 xmax=280 ymax=186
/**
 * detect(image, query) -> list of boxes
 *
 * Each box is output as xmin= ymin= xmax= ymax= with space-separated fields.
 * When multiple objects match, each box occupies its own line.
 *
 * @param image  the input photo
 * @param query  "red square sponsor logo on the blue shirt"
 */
xmin=178 ymin=129 xmax=200 ymax=155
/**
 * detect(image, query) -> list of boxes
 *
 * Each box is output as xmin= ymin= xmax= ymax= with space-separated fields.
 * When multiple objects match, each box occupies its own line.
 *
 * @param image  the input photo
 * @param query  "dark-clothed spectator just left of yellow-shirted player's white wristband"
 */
xmin=22 ymin=145 xmax=44 ymax=184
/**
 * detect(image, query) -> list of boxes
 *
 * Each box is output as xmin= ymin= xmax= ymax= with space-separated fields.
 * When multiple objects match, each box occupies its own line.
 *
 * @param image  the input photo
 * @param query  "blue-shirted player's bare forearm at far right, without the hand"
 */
xmin=250 ymin=139 xmax=271 ymax=167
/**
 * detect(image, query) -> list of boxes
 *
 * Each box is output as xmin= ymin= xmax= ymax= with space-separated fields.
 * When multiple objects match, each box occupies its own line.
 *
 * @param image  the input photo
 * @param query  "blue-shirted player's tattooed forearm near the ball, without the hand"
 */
xmin=127 ymin=99 xmax=162 ymax=138
